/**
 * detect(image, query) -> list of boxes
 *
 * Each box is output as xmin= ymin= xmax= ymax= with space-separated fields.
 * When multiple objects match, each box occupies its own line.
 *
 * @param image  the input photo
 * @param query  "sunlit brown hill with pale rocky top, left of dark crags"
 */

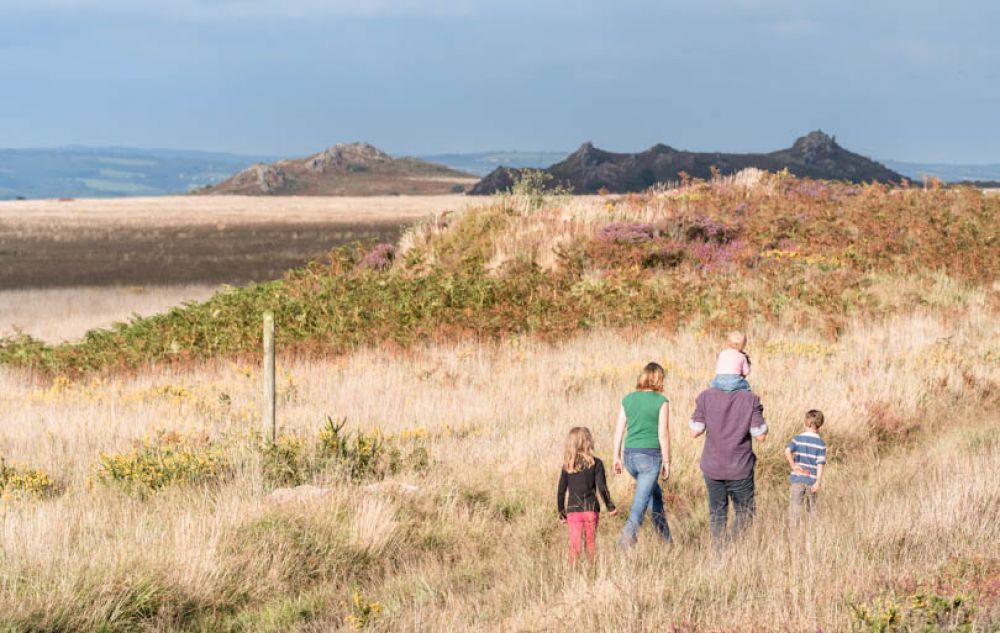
xmin=199 ymin=143 xmax=476 ymax=196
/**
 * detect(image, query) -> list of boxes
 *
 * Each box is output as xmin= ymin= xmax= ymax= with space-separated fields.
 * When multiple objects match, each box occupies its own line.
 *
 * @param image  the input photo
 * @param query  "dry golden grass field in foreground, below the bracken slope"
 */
xmin=0 ymin=293 xmax=1000 ymax=631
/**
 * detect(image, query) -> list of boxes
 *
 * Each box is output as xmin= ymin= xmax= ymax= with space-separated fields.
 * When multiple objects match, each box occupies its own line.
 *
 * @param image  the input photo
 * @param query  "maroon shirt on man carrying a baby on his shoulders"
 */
xmin=689 ymin=389 xmax=767 ymax=481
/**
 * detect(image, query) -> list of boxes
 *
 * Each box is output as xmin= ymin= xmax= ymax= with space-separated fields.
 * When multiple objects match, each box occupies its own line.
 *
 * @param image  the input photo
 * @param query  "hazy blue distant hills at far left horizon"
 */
xmin=0 ymin=147 xmax=272 ymax=200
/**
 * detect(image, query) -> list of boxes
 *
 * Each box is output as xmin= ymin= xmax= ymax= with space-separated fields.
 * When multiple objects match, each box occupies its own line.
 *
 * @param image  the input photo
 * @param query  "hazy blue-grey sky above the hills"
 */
xmin=0 ymin=0 xmax=1000 ymax=163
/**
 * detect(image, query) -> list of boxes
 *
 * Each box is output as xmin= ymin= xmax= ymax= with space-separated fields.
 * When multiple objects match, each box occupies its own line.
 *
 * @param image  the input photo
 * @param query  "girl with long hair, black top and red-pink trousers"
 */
xmin=556 ymin=426 xmax=618 ymax=563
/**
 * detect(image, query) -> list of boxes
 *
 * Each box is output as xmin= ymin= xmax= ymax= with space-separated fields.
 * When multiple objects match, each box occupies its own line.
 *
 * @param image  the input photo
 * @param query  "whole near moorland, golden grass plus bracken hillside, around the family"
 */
xmin=0 ymin=173 xmax=1000 ymax=632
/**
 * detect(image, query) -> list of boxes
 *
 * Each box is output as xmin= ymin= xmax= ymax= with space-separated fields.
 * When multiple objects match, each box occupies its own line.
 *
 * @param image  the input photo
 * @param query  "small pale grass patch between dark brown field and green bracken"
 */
xmin=0 ymin=284 xmax=219 ymax=343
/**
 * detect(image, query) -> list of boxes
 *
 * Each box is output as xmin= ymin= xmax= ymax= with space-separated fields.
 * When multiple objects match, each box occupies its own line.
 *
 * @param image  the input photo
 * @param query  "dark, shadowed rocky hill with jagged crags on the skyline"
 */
xmin=470 ymin=130 xmax=904 ymax=195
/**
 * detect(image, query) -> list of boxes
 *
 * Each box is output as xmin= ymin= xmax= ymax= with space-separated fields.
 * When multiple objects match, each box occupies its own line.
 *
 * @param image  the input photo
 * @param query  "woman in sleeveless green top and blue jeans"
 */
xmin=614 ymin=363 xmax=672 ymax=547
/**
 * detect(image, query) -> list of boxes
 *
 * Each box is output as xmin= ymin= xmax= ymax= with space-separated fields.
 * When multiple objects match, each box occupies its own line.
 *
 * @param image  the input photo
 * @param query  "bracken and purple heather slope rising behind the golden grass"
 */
xmin=0 ymin=176 xmax=1000 ymax=374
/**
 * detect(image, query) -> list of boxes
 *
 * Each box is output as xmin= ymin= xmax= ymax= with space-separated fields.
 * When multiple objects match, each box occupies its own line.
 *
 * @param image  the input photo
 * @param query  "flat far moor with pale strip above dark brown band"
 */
xmin=0 ymin=196 xmax=466 ymax=288
